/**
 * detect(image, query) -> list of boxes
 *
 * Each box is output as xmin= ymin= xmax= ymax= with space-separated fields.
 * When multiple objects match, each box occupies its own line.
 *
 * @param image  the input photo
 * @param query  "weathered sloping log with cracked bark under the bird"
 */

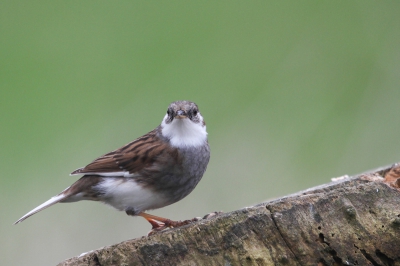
xmin=59 ymin=164 xmax=400 ymax=266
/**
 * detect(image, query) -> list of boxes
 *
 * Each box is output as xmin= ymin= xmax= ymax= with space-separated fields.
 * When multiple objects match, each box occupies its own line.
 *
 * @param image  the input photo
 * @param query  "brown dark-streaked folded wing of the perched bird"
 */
xmin=71 ymin=129 xmax=168 ymax=175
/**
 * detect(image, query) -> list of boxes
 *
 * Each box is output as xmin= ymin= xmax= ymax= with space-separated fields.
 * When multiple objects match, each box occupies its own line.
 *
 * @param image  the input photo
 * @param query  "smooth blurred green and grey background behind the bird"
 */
xmin=0 ymin=1 xmax=400 ymax=265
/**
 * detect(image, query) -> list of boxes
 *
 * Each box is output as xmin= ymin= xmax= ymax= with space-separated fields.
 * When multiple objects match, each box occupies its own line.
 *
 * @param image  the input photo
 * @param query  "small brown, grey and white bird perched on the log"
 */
xmin=14 ymin=101 xmax=210 ymax=232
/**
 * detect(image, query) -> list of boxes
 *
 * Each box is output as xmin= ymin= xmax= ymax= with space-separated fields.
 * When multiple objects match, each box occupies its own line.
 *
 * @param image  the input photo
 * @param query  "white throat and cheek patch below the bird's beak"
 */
xmin=161 ymin=113 xmax=207 ymax=148
